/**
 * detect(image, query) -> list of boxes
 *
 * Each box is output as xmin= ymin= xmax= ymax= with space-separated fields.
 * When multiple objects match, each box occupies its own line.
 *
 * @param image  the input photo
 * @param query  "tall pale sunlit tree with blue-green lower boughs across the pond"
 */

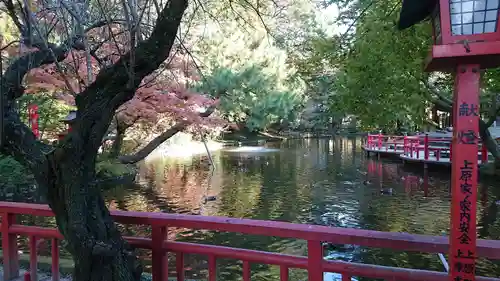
xmin=186 ymin=0 xmax=326 ymax=131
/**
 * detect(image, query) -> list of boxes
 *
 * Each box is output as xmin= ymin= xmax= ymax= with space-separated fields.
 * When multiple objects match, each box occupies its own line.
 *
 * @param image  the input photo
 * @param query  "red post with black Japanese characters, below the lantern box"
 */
xmin=449 ymin=65 xmax=480 ymax=281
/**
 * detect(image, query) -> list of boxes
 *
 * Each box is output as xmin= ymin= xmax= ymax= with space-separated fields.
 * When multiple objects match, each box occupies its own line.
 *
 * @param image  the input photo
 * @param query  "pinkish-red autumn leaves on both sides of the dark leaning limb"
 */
xmin=0 ymin=19 xmax=223 ymax=131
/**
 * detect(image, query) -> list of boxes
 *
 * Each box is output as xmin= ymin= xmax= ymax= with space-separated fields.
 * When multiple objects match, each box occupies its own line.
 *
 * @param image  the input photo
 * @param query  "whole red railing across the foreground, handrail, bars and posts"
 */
xmin=0 ymin=202 xmax=500 ymax=281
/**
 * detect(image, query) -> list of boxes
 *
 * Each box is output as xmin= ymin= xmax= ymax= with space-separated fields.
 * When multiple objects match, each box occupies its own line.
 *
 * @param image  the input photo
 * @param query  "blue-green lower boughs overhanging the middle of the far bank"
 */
xmin=197 ymin=66 xmax=303 ymax=131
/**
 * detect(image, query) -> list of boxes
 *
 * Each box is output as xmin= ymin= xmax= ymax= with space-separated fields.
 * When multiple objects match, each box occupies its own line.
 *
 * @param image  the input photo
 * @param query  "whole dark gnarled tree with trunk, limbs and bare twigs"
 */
xmin=0 ymin=0 xmax=188 ymax=280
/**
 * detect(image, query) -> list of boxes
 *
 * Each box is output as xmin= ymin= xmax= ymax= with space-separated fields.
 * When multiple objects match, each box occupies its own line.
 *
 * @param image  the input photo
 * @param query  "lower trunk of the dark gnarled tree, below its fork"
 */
xmin=47 ymin=150 xmax=142 ymax=281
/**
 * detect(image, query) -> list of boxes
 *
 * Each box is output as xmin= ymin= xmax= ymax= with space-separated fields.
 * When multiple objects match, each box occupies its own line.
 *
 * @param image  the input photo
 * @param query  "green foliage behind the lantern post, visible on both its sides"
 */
xmin=312 ymin=0 xmax=500 ymax=131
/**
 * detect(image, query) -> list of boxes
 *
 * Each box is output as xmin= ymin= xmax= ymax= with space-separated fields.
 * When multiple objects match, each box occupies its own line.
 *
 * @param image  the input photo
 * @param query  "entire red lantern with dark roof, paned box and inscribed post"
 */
xmin=399 ymin=0 xmax=500 ymax=281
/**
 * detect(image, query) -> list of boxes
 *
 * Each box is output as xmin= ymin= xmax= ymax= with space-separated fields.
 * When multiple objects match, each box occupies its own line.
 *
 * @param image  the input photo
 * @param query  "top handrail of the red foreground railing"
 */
xmin=0 ymin=202 xmax=500 ymax=259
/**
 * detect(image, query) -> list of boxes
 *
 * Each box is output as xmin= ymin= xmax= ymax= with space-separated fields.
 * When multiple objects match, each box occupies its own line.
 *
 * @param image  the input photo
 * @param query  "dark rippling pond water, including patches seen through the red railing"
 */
xmin=7 ymin=138 xmax=500 ymax=281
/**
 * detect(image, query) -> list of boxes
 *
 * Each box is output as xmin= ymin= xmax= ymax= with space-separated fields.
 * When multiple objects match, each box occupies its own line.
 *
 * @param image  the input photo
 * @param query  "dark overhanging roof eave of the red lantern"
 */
xmin=398 ymin=0 xmax=437 ymax=30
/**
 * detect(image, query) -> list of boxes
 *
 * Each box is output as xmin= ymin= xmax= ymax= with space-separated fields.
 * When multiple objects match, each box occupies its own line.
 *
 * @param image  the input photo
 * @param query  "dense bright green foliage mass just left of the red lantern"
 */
xmin=333 ymin=1 xmax=431 ymax=128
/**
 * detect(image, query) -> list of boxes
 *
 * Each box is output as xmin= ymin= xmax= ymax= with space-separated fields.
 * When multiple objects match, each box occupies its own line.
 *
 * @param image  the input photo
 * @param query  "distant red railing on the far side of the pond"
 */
xmin=365 ymin=134 xmax=488 ymax=163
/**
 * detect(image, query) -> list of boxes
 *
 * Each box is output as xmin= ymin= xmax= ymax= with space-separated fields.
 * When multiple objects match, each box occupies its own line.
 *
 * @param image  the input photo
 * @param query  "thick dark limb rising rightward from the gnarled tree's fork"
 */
xmin=69 ymin=0 xmax=188 ymax=157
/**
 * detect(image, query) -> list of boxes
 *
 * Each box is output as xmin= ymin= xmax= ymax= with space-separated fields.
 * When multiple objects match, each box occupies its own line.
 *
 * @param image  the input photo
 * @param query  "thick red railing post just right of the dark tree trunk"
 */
xmin=151 ymin=225 xmax=168 ymax=281
